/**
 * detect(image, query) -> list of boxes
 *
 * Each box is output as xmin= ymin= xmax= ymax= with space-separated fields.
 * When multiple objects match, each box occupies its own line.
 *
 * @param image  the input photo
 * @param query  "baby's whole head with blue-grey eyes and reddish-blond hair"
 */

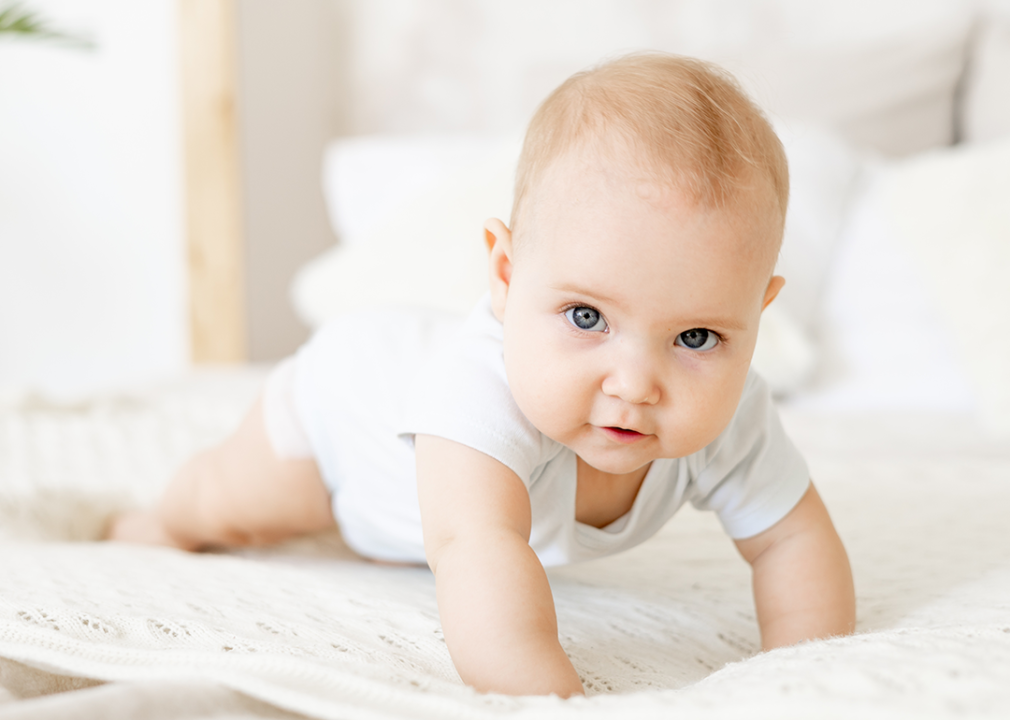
xmin=487 ymin=50 xmax=789 ymax=473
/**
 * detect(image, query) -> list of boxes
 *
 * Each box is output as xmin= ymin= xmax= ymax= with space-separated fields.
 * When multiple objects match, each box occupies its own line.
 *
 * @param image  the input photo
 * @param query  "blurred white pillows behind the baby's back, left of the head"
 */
xmin=292 ymin=136 xmax=520 ymax=327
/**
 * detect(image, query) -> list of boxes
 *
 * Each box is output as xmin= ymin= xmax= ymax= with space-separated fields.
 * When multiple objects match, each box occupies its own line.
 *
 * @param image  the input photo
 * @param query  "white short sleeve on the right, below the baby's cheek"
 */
xmin=691 ymin=370 xmax=810 ymax=539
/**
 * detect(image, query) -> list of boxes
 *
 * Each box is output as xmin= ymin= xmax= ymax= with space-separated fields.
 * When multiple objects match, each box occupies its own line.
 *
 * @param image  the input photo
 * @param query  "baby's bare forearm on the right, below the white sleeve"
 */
xmin=736 ymin=485 xmax=855 ymax=650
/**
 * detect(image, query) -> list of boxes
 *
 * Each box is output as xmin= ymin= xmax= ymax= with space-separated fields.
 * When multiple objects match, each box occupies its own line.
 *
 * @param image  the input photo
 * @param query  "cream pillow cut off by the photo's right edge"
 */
xmin=881 ymin=135 xmax=1010 ymax=436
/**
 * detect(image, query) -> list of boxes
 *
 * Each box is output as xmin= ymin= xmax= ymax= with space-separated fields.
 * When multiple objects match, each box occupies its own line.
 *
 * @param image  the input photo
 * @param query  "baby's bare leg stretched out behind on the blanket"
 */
xmin=108 ymin=398 xmax=334 ymax=549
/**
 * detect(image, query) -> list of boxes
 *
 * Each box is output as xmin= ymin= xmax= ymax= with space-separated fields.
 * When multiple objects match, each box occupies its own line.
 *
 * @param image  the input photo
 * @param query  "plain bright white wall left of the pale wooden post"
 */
xmin=0 ymin=0 xmax=188 ymax=397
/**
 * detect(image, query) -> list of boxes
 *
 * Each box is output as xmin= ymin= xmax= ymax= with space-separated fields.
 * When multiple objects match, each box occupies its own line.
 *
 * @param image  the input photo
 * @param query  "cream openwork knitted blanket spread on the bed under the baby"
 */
xmin=0 ymin=376 xmax=1010 ymax=719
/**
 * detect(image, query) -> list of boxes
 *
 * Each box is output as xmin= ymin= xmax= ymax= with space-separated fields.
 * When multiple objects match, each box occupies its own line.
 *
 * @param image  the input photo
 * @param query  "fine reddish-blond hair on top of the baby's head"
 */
xmin=511 ymin=53 xmax=789 ymax=240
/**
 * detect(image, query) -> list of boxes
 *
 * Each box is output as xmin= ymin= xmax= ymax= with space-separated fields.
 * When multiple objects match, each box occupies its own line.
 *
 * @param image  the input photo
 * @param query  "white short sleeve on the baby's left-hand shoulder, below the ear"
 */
xmin=399 ymin=296 xmax=561 ymax=487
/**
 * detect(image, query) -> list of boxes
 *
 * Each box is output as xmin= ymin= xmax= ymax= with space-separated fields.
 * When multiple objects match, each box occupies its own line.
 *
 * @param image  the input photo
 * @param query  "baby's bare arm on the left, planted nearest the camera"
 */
xmin=416 ymin=435 xmax=583 ymax=697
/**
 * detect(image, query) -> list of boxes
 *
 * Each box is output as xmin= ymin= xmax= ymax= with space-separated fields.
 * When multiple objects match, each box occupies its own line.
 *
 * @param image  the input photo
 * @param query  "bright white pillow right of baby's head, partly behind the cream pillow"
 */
xmin=790 ymin=170 xmax=974 ymax=413
